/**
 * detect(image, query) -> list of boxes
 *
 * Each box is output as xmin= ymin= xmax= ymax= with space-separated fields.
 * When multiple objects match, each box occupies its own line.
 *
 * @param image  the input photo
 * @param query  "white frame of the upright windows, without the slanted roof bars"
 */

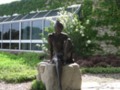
xmin=0 ymin=16 xmax=64 ymax=52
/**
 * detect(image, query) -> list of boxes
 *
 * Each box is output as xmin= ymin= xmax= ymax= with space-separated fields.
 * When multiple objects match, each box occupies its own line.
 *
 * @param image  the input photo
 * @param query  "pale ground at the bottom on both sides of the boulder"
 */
xmin=0 ymin=74 xmax=120 ymax=90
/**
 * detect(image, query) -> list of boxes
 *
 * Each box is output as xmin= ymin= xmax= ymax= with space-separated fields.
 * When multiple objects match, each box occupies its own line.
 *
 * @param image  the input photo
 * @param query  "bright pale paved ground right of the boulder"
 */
xmin=82 ymin=73 xmax=120 ymax=90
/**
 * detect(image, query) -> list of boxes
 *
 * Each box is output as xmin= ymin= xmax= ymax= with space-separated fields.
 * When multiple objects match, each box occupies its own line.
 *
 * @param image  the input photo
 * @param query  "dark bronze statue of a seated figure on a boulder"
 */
xmin=48 ymin=21 xmax=73 ymax=90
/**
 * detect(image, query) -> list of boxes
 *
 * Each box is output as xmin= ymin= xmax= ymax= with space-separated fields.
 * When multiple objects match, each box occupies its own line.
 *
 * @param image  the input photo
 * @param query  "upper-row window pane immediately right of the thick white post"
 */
xmin=21 ymin=21 xmax=30 ymax=40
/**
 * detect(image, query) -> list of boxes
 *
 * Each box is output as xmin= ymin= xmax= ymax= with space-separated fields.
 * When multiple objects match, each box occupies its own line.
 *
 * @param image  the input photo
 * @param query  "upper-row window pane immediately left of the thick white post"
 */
xmin=11 ymin=23 xmax=19 ymax=40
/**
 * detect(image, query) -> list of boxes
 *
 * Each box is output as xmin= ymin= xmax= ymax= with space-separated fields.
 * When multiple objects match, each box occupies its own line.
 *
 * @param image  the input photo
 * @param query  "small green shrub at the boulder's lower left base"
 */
xmin=31 ymin=80 xmax=46 ymax=90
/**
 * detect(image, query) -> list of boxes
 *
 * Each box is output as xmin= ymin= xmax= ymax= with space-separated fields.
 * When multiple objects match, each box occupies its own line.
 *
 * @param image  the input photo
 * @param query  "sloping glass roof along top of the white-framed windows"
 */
xmin=0 ymin=4 xmax=81 ymax=23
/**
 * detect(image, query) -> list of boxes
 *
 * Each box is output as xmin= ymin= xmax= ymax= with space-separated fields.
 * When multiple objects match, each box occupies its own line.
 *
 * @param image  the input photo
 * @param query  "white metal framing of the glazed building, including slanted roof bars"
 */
xmin=0 ymin=5 xmax=81 ymax=52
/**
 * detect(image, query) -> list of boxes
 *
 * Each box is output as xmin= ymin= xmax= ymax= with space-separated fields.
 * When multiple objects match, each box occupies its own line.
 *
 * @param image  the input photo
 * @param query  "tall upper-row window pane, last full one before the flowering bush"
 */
xmin=32 ymin=20 xmax=43 ymax=39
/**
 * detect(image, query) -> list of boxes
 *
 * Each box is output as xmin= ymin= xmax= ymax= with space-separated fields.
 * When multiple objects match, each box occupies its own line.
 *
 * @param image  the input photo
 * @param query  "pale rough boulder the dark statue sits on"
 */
xmin=37 ymin=62 xmax=82 ymax=90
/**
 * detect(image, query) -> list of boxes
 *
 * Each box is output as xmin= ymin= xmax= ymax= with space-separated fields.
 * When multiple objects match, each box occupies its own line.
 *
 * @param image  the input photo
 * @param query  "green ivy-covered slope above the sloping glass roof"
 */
xmin=0 ymin=0 xmax=81 ymax=16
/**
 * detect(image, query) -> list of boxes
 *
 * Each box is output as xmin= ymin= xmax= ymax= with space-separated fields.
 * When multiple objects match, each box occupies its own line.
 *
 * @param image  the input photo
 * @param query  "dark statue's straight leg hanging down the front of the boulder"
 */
xmin=55 ymin=59 xmax=62 ymax=90
